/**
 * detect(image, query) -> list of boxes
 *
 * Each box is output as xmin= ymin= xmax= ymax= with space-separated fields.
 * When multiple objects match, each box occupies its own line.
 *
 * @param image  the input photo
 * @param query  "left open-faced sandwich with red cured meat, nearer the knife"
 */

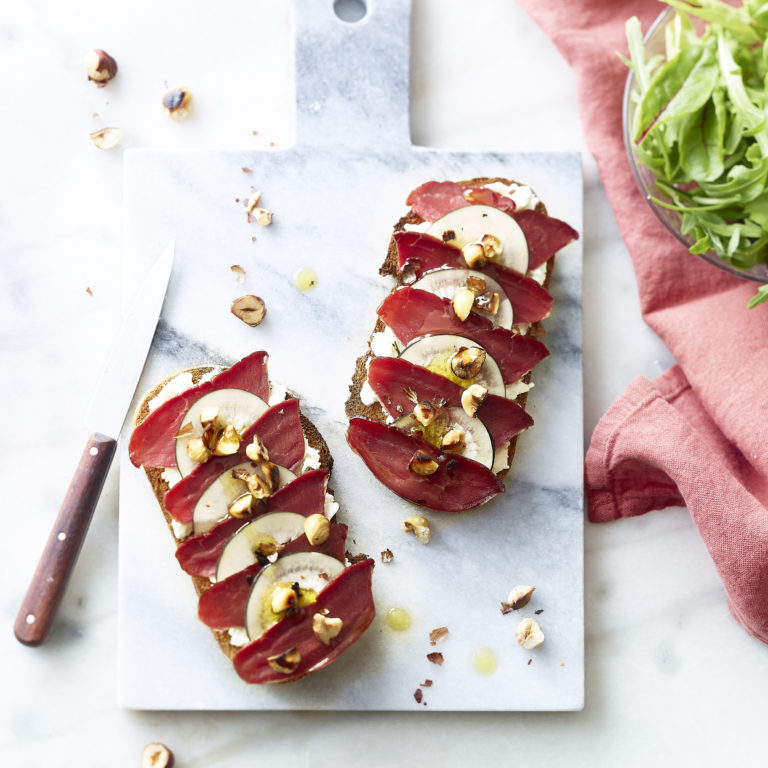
xmin=129 ymin=352 xmax=374 ymax=683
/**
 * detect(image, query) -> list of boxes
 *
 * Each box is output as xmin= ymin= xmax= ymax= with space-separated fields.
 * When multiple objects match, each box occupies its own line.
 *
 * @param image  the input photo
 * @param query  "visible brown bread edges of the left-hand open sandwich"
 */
xmin=133 ymin=366 xmax=333 ymax=660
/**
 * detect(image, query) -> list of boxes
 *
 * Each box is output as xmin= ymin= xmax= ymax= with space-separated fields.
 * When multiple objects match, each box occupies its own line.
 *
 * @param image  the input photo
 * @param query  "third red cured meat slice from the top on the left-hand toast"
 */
xmin=176 ymin=469 xmax=328 ymax=576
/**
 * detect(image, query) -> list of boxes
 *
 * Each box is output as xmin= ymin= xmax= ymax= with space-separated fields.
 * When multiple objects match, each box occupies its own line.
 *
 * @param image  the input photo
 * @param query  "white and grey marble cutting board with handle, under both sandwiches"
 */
xmin=119 ymin=0 xmax=584 ymax=711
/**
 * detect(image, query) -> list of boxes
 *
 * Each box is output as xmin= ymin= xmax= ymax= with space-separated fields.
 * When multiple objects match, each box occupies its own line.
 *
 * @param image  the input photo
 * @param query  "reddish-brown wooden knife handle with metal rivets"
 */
xmin=13 ymin=433 xmax=117 ymax=645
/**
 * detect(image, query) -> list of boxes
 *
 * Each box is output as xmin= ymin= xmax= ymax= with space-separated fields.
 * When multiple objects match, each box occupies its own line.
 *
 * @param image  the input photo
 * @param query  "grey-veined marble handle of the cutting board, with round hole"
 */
xmin=294 ymin=0 xmax=411 ymax=151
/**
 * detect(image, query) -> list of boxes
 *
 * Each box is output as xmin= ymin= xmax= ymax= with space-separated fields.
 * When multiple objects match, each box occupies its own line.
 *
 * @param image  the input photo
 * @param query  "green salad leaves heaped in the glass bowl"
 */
xmin=624 ymin=0 xmax=768 ymax=307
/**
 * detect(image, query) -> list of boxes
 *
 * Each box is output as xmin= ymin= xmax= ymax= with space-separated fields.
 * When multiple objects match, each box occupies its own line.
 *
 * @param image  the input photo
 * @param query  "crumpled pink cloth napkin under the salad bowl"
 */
xmin=518 ymin=0 xmax=768 ymax=643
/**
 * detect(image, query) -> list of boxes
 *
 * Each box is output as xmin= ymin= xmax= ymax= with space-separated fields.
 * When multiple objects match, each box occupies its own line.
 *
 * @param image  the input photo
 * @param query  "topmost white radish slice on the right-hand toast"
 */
xmin=427 ymin=205 xmax=528 ymax=274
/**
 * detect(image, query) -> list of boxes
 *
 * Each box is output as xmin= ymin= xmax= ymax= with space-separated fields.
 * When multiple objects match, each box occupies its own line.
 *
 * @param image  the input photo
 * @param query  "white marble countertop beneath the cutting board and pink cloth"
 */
xmin=0 ymin=0 xmax=768 ymax=768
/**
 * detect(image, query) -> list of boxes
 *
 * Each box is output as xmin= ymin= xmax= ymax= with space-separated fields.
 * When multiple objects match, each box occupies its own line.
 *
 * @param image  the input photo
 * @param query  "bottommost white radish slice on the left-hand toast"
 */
xmin=245 ymin=552 xmax=344 ymax=640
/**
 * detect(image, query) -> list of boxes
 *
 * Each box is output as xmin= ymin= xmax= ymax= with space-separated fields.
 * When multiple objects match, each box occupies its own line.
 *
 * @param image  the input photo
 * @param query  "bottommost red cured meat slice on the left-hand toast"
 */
xmin=233 ymin=559 xmax=376 ymax=683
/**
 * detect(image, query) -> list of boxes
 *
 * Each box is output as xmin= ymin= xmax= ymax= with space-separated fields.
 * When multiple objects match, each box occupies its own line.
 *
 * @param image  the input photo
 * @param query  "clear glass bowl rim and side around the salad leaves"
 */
xmin=622 ymin=8 xmax=768 ymax=283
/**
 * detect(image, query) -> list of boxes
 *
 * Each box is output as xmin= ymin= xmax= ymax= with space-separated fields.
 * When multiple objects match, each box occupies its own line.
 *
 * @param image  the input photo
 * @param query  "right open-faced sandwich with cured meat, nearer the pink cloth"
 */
xmin=346 ymin=178 xmax=578 ymax=512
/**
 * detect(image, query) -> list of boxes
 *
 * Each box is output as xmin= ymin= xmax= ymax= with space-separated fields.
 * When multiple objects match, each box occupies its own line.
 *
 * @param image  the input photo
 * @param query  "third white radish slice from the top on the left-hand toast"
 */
xmin=216 ymin=512 xmax=306 ymax=581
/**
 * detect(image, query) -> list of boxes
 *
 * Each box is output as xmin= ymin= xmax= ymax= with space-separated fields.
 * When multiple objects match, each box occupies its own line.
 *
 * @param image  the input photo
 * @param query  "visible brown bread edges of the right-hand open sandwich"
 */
xmin=344 ymin=176 xmax=555 ymax=480
